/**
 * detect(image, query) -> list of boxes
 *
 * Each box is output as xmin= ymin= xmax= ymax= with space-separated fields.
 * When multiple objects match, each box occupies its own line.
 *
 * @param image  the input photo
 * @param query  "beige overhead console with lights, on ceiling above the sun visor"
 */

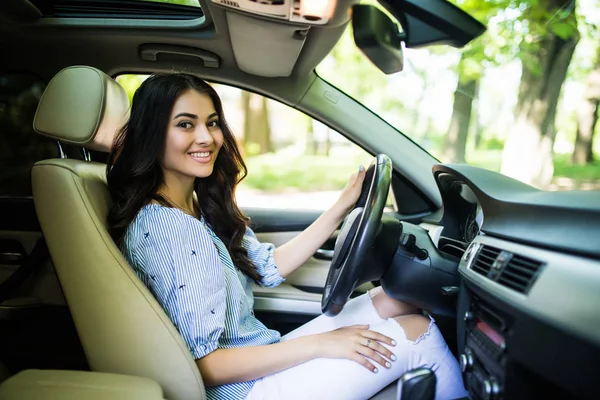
xmin=211 ymin=0 xmax=336 ymax=25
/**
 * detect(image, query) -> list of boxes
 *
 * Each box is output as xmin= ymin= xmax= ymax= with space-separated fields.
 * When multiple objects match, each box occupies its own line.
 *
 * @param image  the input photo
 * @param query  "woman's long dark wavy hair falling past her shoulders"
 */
xmin=106 ymin=74 xmax=261 ymax=282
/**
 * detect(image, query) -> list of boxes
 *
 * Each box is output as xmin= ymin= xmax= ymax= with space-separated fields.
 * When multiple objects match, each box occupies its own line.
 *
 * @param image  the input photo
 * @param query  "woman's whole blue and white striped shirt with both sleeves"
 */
xmin=122 ymin=204 xmax=283 ymax=399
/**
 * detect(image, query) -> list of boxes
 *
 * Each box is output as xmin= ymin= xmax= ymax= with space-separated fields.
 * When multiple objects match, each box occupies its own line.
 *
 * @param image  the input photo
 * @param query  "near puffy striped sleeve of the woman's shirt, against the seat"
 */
xmin=138 ymin=209 xmax=226 ymax=359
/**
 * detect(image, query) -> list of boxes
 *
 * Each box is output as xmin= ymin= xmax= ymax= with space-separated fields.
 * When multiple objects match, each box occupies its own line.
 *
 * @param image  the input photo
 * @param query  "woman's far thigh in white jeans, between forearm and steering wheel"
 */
xmin=281 ymin=293 xmax=385 ymax=341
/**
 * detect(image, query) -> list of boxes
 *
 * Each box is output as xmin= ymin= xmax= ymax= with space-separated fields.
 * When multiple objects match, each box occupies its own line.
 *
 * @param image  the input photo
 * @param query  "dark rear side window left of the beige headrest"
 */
xmin=0 ymin=74 xmax=58 ymax=197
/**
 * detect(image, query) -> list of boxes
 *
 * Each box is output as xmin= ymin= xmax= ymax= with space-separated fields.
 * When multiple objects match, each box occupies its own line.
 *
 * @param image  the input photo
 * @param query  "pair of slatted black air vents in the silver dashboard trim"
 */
xmin=470 ymin=245 xmax=543 ymax=293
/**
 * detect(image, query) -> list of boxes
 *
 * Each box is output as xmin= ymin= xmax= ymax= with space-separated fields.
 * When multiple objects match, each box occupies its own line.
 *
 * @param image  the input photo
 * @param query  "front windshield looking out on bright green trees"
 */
xmin=317 ymin=0 xmax=600 ymax=190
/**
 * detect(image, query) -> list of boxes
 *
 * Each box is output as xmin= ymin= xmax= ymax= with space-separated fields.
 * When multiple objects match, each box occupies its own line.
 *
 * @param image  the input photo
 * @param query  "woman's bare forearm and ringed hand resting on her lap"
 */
xmin=196 ymin=325 xmax=396 ymax=386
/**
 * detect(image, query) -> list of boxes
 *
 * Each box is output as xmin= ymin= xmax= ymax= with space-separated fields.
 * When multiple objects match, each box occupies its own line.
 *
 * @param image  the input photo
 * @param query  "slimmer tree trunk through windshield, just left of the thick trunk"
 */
xmin=443 ymin=63 xmax=477 ymax=163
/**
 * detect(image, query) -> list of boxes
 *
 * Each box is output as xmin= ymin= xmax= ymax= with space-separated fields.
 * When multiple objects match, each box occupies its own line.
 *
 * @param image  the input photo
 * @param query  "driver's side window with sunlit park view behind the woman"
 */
xmin=117 ymin=75 xmax=393 ymax=210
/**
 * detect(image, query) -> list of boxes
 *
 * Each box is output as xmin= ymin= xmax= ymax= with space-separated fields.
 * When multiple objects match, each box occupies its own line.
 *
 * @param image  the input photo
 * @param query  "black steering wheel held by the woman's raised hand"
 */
xmin=321 ymin=154 xmax=392 ymax=317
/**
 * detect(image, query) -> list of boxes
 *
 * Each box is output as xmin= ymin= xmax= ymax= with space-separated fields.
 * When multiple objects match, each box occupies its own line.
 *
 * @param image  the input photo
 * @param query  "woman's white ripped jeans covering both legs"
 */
xmin=247 ymin=293 xmax=467 ymax=400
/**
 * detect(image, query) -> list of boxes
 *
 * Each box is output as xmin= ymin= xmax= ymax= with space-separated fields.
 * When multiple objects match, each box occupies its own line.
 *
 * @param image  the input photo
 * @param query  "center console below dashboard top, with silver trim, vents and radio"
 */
xmin=457 ymin=236 xmax=600 ymax=400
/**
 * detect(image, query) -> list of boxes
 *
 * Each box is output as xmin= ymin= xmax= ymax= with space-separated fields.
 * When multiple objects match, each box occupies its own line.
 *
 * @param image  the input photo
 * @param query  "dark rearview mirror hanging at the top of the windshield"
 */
xmin=352 ymin=4 xmax=404 ymax=74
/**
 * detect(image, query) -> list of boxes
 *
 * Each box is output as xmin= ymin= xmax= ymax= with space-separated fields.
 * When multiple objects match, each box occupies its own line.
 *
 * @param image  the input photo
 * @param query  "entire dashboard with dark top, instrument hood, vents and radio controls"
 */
xmin=421 ymin=164 xmax=600 ymax=400
